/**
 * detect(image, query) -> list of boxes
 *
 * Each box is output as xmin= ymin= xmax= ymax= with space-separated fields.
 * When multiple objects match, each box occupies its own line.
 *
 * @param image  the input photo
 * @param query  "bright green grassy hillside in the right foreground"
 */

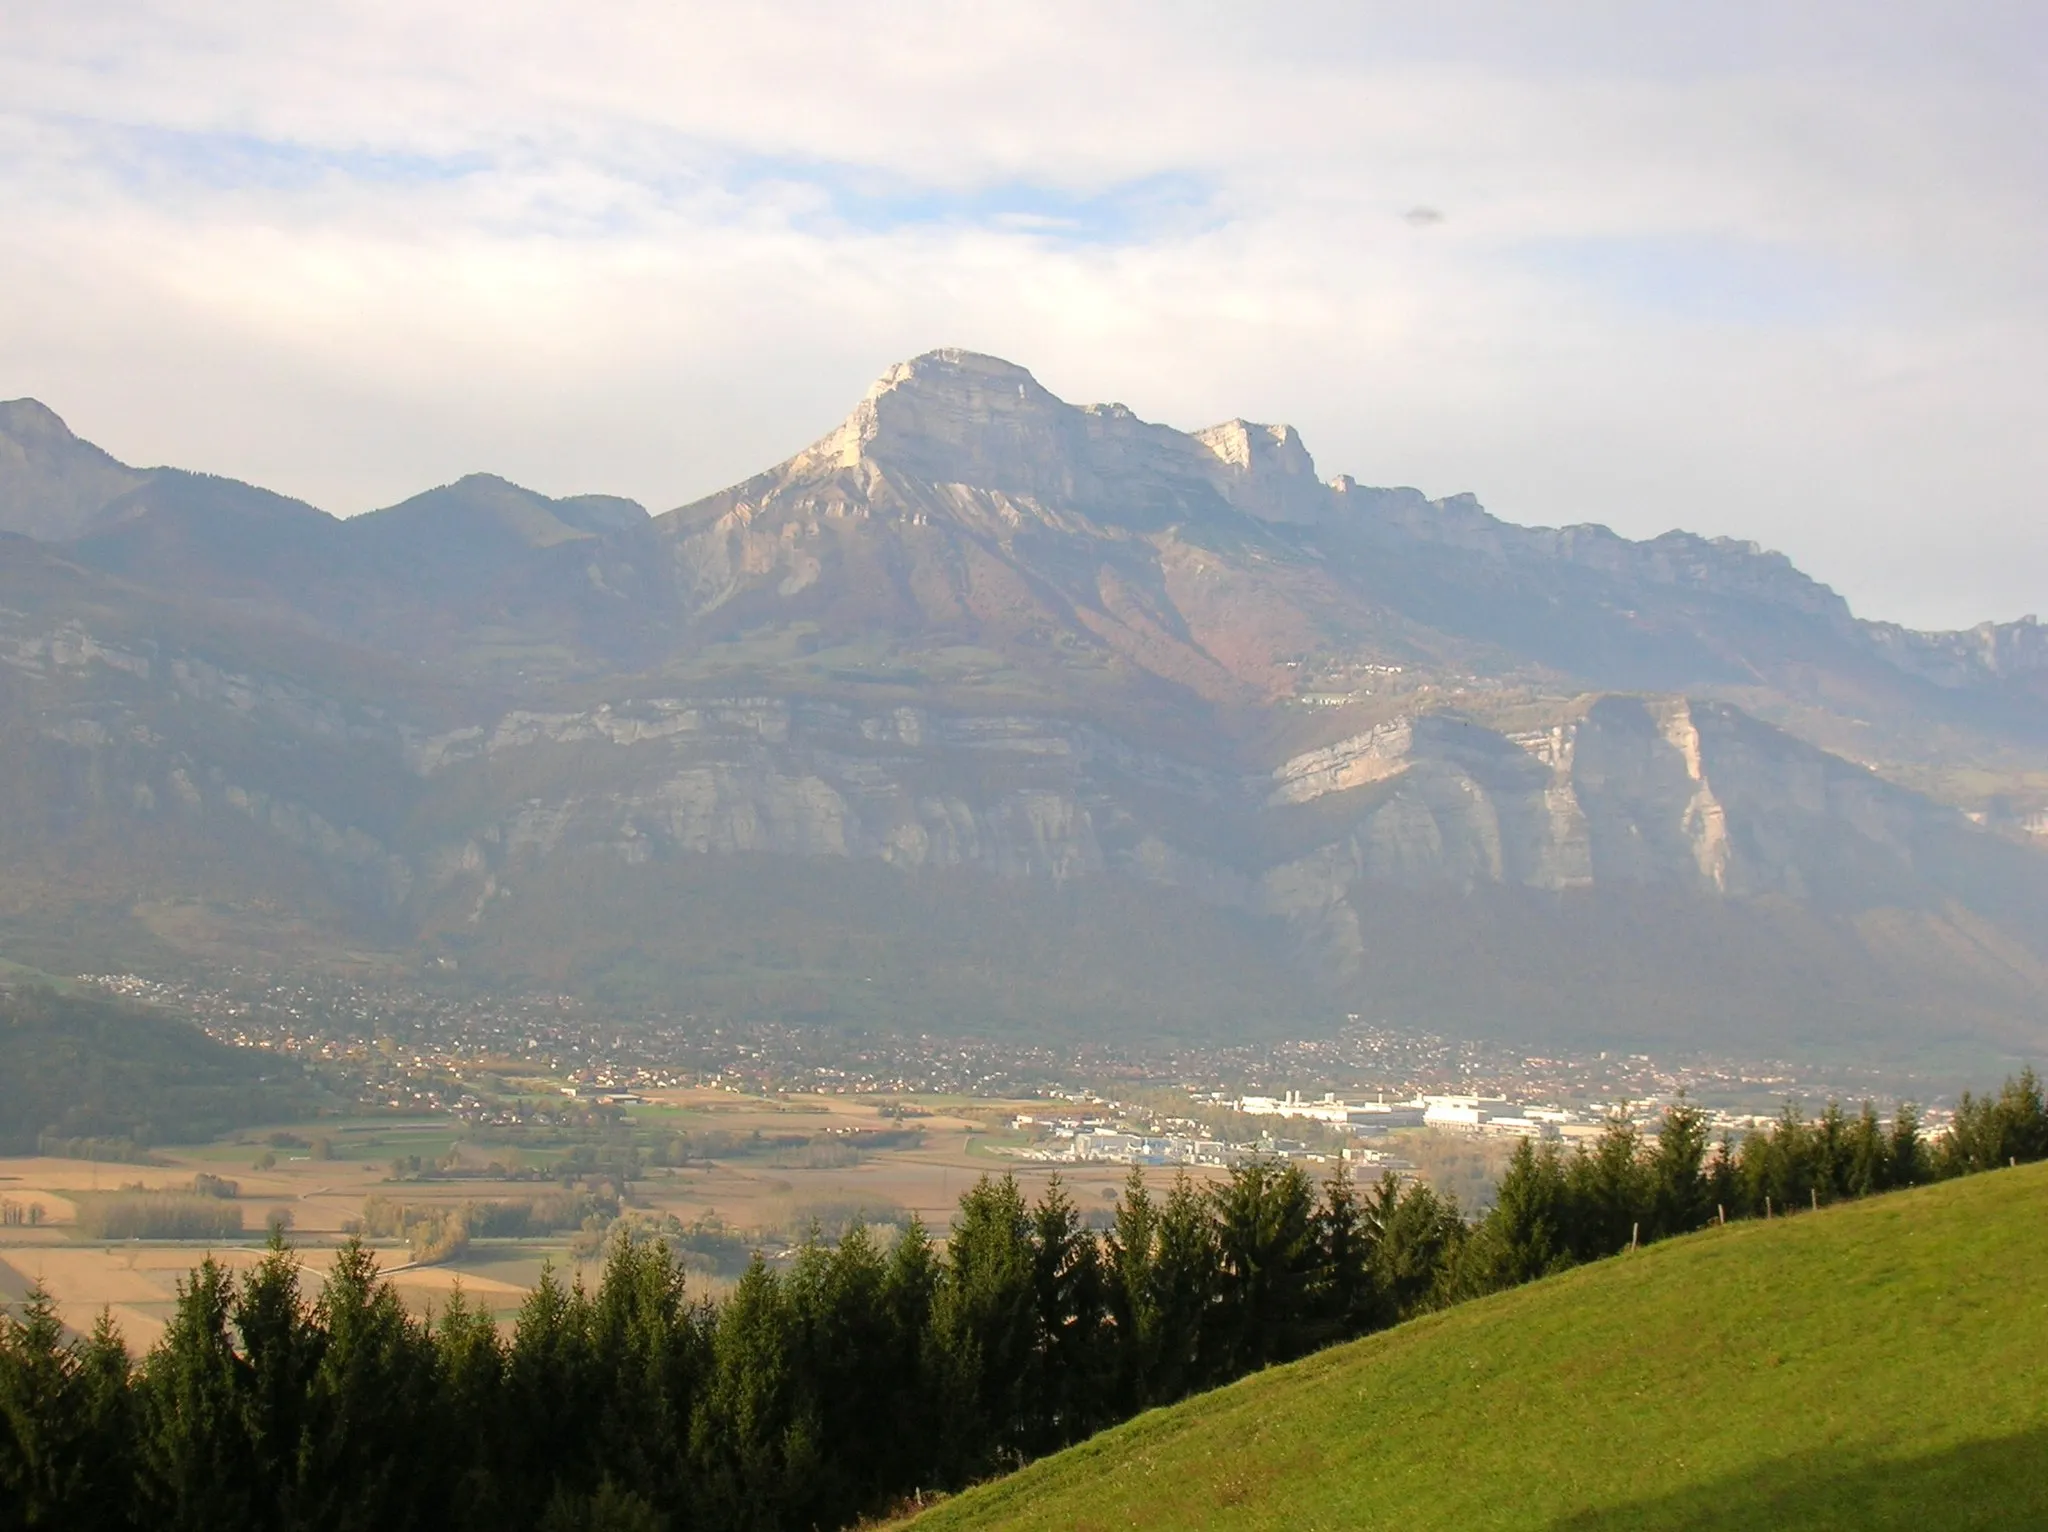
xmin=915 ymin=1165 xmax=2048 ymax=1532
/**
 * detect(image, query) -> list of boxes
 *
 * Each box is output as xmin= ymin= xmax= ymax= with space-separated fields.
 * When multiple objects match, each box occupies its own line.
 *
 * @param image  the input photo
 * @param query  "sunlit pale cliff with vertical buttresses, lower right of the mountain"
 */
xmin=1262 ymin=696 xmax=2025 ymax=946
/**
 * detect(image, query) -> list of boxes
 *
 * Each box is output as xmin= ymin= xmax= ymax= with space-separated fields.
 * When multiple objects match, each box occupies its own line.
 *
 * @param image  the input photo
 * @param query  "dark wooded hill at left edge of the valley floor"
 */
xmin=0 ymin=987 xmax=313 ymax=1163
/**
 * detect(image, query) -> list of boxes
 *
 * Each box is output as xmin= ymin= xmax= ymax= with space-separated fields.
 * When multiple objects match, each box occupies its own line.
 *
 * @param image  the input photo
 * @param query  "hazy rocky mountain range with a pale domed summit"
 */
xmin=0 ymin=350 xmax=2048 ymax=1057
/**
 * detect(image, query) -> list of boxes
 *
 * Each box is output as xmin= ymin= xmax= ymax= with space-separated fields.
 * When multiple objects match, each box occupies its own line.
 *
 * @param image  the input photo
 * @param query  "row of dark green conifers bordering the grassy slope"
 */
xmin=0 ymin=1071 xmax=2048 ymax=1532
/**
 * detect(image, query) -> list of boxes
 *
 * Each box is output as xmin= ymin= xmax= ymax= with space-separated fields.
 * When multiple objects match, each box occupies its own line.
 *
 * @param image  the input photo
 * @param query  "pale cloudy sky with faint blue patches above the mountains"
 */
xmin=0 ymin=0 xmax=2048 ymax=625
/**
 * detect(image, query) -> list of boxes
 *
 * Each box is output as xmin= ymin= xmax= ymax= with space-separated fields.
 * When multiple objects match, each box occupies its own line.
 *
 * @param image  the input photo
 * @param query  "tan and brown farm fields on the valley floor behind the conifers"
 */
xmin=0 ymin=1090 xmax=1179 ymax=1350
